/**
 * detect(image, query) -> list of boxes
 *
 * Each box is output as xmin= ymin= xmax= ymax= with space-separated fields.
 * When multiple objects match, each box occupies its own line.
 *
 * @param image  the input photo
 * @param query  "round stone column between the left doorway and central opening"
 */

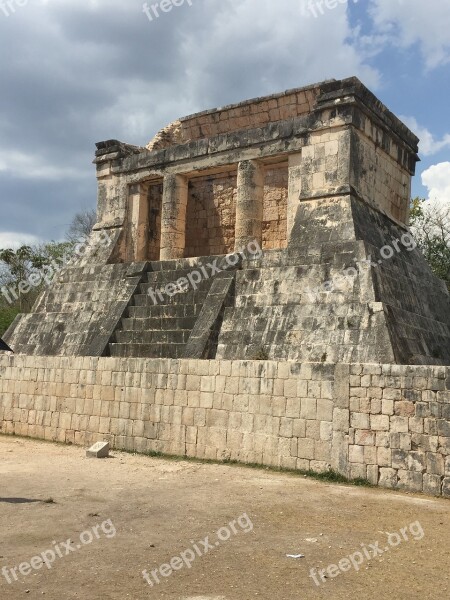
xmin=160 ymin=175 xmax=188 ymax=260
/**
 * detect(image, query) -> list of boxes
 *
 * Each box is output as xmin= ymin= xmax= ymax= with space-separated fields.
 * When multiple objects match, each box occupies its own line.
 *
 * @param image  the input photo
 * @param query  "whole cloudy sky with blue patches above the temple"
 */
xmin=0 ymin=0 xmax=450 ymax=247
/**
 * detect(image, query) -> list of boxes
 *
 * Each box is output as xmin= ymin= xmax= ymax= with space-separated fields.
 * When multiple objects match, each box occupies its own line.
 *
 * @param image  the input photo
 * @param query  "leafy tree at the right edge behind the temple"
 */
xmin=410 ymin=198 xmax=450 ymax=290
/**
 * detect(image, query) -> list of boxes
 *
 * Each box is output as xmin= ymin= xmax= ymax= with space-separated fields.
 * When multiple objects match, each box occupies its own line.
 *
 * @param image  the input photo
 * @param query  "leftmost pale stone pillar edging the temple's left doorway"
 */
xmin=127 ymin=184 xmax=148 ymax=262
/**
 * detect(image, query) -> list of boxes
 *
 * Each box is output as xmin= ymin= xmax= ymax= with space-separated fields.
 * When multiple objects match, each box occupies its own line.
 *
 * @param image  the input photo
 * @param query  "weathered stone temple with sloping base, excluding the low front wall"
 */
xmin=5 ymin=78 xmax=450 ymax=365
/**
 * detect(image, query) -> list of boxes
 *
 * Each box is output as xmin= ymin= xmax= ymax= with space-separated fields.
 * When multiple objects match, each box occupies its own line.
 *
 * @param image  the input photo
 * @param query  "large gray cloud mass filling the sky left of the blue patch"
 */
xmin=0 ymin=0 xmax=378 ymax=244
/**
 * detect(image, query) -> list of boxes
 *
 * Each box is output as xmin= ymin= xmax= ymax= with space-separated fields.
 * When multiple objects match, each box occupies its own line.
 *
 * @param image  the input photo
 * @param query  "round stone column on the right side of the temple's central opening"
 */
xmin=235 ymin=160 xmax=264 ymax=251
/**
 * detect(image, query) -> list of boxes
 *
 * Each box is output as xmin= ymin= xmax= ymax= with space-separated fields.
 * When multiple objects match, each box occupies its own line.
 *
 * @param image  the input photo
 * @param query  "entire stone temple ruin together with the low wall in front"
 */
xmin=0 ymin=78 xmax=450 ymax=497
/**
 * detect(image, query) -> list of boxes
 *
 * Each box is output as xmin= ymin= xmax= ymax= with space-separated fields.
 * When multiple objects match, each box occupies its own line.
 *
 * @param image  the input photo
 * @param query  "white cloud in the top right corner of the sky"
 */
xmin=370 ymin=0 xmax=450 ymax=69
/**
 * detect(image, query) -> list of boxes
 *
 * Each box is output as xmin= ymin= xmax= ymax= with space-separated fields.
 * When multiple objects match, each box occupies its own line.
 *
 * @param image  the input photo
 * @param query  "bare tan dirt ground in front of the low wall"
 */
xmin=0 ymin=436 xmax=450 ymax=600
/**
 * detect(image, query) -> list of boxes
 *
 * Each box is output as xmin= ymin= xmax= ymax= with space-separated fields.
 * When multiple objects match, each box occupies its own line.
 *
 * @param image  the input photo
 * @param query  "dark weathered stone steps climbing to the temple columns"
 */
xmin=109 ymin=256 xmax=234 ymax=358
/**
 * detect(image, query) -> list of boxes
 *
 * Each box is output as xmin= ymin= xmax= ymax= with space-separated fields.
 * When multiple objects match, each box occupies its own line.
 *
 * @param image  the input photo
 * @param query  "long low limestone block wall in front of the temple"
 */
xmin=0 ymin=356 xmax=450 ymax=497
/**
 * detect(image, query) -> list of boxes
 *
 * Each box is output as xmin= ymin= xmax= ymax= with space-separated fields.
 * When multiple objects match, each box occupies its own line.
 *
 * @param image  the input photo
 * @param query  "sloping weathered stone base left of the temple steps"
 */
xmin=4 ymin=264 xmax=139 ymax=356
